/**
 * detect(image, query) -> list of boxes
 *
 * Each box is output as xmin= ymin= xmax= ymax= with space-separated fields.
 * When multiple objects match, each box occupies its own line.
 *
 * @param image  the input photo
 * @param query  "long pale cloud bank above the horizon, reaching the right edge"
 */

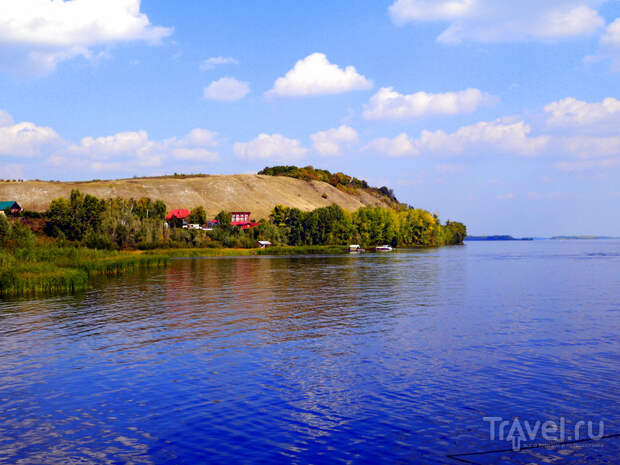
xmin=363 ymin=97 xmax=620 ymax=171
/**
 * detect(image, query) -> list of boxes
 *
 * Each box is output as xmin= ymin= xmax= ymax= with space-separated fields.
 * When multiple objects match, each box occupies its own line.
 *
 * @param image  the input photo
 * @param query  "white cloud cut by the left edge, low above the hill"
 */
xmin=0 ymin=110 xmax=62 ymax=158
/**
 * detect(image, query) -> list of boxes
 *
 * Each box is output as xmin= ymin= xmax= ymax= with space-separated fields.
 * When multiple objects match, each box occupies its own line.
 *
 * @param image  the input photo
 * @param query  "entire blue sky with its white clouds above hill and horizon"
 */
xmin=0 ymin=0 xmax=620 ymax=236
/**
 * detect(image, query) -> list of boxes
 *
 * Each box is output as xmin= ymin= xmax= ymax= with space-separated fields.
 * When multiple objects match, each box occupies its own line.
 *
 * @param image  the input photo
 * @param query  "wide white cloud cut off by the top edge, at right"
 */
xmin=389 ymin=0 xmax=605 ymax=44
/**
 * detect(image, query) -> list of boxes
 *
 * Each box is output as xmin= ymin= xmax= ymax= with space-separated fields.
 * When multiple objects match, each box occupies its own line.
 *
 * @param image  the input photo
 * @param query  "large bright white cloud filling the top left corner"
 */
xmin=0 ymin=0 xmax=172 ymax=75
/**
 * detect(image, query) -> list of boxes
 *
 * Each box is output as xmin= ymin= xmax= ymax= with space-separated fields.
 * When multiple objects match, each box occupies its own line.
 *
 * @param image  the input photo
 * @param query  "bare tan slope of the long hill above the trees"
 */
xmin=0 ymin=174 xmax=387 ymax=219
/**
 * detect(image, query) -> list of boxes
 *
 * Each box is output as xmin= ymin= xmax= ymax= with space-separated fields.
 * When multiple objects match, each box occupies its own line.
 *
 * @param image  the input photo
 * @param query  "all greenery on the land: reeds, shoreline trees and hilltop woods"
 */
xmin=0 ymin=166 xmax=467 ymax=297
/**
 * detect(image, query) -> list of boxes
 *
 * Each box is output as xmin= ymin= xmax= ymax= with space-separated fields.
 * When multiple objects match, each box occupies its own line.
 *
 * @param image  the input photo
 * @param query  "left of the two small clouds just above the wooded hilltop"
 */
xmin=233 ymin=133 xmax=308 ymax=161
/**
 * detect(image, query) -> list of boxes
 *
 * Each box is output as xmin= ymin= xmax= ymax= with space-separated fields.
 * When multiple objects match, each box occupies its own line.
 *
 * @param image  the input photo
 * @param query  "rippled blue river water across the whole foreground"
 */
xmin=0 ymin=240 xmax=620 ymax=465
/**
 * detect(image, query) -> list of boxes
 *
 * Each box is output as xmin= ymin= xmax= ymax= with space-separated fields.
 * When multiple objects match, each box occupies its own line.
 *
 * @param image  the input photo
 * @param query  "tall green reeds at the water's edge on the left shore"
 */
xmin=0 ymin=247 xmax=169 ymax=296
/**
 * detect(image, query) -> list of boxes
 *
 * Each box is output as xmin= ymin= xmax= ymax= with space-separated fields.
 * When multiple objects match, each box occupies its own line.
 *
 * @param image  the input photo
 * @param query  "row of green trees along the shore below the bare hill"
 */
xmin=0 ymin=190 xmax=467 ymax=250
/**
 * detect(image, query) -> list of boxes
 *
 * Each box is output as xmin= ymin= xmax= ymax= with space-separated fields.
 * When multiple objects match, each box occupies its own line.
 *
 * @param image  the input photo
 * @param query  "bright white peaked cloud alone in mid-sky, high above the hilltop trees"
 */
xmin=265 ymin=53 xmax=373 ymax=97
